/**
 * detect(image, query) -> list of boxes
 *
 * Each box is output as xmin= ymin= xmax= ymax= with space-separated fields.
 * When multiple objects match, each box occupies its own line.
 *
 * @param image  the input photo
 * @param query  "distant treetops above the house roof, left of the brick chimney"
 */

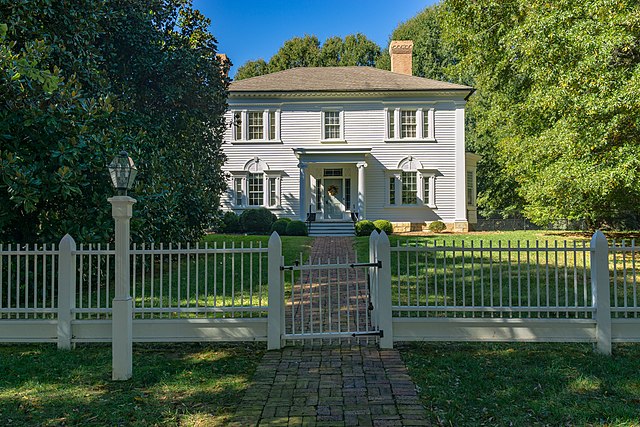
xmin=235 ymin=33 xmax=380 ymax=80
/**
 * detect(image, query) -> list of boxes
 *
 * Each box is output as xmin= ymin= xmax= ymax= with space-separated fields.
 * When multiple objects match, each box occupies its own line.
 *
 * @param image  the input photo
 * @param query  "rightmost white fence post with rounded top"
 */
xmin=591 ymin=230 xmax=611 ymax=354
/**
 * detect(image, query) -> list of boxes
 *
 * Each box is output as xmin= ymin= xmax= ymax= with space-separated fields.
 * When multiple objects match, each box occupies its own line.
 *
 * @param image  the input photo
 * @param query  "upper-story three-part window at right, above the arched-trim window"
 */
xmin=386 ymin=108 xmax=435 ymax=141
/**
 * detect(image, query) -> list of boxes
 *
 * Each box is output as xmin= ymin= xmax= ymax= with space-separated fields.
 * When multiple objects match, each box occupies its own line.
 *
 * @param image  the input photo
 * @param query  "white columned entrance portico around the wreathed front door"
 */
xmin=293 ymin=146 xmax=371 ymax=222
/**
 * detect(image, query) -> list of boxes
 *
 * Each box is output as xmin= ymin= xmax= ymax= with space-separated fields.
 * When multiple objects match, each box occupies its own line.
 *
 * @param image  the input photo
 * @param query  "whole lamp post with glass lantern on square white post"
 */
xmin=107 ymin=151 xmax=138 ymax=381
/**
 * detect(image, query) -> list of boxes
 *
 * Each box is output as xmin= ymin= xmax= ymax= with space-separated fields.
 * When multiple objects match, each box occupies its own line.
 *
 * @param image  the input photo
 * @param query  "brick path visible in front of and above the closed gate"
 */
xmin=231 ymin=237 xmax=428 ymax=427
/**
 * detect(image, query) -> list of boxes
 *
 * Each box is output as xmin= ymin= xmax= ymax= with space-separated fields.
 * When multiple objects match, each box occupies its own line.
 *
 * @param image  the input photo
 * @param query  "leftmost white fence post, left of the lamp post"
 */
xmin=58 ymin=234 xmax=76 ymax=350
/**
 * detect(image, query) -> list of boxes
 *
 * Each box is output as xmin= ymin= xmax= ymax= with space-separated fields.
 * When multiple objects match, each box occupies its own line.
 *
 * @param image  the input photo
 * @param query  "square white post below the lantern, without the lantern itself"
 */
xmin=107 ymin=196 xmax=136 ymax=380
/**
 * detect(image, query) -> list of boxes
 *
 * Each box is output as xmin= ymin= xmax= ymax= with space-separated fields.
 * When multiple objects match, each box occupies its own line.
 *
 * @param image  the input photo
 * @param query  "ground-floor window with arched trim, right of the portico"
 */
xmin=386 ymin=156 xmax=437 ymax=208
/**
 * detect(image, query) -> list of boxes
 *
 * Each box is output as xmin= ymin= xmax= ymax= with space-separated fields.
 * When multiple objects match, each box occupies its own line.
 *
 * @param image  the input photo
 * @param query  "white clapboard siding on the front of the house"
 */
xmin=221 ymin=98 xmax=464 ymax=222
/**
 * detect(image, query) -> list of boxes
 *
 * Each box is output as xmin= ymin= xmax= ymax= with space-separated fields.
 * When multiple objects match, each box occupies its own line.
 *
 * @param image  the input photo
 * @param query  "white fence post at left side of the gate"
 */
xmin=267 ymin=231 xmax=284 ymax=350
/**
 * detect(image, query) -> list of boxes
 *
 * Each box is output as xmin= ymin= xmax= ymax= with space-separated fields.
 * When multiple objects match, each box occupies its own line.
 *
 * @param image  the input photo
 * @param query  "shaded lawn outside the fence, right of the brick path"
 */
xmin=400 ymin=343 xmax=640 ymax=426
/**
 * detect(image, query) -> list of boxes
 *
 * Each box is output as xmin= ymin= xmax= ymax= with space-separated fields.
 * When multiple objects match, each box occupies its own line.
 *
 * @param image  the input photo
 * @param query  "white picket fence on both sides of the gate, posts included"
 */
xmin=0 ymin=233 xmax=640 ymax=353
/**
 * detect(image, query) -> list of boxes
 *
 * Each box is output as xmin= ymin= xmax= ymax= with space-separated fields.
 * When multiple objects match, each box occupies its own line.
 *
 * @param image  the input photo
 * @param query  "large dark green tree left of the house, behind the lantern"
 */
xmin=0 ymin=0 xmax=228 ymax=242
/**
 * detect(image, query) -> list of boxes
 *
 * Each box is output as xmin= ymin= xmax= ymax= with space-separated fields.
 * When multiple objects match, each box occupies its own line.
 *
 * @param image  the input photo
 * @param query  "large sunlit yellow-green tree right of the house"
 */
xmin=443 ymin=0 xmax=640 ymax=226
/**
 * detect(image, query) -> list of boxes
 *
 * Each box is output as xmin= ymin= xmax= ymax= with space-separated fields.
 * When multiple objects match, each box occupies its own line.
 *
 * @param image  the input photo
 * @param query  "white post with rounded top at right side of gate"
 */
xmin=376 ymin=230 xmax=393 ymax=348
